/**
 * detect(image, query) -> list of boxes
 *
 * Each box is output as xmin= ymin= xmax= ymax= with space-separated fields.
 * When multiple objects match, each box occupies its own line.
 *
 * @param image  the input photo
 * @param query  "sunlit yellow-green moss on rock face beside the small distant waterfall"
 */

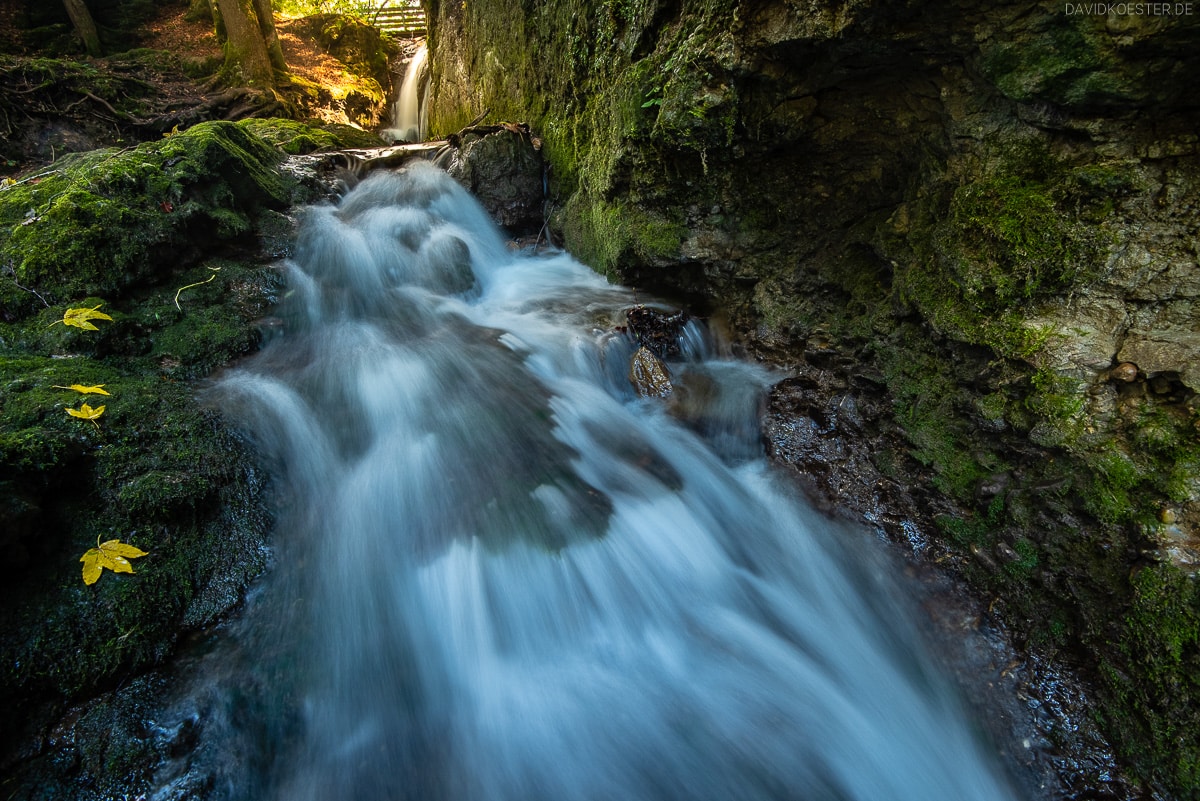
xmin=431 ymin=0 xmax=738 ymax=273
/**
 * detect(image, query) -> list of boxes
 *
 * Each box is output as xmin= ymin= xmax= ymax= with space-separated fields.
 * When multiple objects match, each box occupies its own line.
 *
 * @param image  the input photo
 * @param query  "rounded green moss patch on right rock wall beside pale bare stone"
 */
xmin=882 ymin=139 xmax=1108 ymax=361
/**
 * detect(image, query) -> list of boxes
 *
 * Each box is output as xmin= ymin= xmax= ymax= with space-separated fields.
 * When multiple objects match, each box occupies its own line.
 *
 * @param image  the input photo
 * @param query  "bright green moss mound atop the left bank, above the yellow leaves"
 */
xmin=0 ymin=122 xmax=289 ymax=317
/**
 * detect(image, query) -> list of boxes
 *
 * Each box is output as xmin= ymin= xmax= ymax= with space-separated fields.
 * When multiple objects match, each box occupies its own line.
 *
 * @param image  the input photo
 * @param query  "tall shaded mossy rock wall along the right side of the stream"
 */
xmin=428 ymin=0 xmax=1200 ymax=799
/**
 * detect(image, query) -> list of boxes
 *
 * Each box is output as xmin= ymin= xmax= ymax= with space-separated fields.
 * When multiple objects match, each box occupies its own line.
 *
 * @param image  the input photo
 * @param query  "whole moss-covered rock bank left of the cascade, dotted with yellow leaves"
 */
xmin=0 ymin=122 xmax=355 ymax=760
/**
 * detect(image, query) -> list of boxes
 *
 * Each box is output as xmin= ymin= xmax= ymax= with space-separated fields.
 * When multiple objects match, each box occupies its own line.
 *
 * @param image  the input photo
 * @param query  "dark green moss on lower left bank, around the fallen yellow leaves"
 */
xmin=0 ymin=261 xmax=278 ymax=753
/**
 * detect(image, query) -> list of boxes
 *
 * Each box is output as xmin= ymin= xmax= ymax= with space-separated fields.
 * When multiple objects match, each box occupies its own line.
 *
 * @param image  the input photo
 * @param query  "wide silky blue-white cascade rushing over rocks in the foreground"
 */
xmin=174 ymin=164 xmax=1010 ymax=801
